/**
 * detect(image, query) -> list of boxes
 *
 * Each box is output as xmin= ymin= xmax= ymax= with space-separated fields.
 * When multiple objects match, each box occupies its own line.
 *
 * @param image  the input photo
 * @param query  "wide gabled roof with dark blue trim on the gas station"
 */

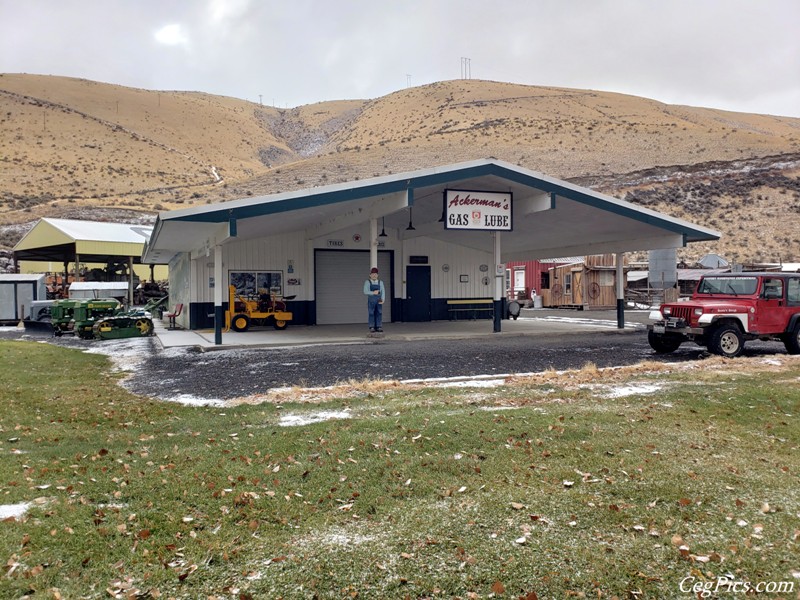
xmin=143 ymin=159 xmax=719 ymax=264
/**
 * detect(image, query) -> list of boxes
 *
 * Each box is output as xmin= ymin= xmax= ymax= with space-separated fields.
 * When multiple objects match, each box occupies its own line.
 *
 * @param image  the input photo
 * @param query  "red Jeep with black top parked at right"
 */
xmin=647 ymin=273 xmax=800 ymax=358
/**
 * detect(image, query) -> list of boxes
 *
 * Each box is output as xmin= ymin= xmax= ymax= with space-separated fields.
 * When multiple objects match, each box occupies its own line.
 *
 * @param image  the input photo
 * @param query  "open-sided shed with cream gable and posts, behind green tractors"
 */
xmin=14 ymin=218 xmax=166 ymax=302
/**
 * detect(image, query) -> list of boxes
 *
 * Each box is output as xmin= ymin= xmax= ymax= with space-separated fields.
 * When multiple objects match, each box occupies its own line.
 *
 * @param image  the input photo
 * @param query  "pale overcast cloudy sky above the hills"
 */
xmin=0 ymin=0 xmax=800 ymax=117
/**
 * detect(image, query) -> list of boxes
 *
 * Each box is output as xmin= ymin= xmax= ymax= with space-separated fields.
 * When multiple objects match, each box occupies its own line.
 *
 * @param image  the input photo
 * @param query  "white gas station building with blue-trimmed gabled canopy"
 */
xmin=142 ymin=160 xmax=719 ymax=344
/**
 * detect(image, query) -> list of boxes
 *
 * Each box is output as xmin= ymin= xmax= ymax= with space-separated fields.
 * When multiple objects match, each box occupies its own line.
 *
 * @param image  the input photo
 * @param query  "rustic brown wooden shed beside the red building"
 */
xmin=542 ymin=254 xmax=624 ymax=310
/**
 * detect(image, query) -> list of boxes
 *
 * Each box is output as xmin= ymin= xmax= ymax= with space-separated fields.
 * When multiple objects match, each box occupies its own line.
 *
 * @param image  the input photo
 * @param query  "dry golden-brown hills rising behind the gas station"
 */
xmin=0 ymin=74 xmax=800 ymax=261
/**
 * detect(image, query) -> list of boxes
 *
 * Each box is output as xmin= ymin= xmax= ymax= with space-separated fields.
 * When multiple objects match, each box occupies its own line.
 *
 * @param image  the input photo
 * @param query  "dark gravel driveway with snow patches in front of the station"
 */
xmin=0 ymin=328 xmax=785 ymax=403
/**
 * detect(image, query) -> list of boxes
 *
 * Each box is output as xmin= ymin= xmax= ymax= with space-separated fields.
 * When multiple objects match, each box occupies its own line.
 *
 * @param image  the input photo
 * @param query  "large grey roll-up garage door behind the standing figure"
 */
xmin=315 ymin=250 xmax=392 ymax=326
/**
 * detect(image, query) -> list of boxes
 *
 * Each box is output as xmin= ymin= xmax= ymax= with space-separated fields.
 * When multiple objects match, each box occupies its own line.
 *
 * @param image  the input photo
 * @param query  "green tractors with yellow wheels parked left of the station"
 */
xmin=51 ymin=298 xmax=153 ymax=340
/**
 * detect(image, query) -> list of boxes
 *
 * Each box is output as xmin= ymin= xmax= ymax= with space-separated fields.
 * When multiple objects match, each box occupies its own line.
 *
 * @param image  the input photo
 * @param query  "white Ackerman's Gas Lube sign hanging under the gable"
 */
xmin=444 ymin=190 xmax=512 ymax=231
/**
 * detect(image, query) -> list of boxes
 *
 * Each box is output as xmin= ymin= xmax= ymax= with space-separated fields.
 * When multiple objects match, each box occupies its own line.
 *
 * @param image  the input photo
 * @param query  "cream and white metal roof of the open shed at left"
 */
xmin=14 ymin=218 xmax=153 ymax=263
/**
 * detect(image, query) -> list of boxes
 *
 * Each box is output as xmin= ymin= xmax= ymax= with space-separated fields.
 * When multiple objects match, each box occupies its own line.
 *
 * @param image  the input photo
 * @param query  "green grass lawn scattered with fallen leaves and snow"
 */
xmin=0 ymin=341 xmax=800 ymax=599
